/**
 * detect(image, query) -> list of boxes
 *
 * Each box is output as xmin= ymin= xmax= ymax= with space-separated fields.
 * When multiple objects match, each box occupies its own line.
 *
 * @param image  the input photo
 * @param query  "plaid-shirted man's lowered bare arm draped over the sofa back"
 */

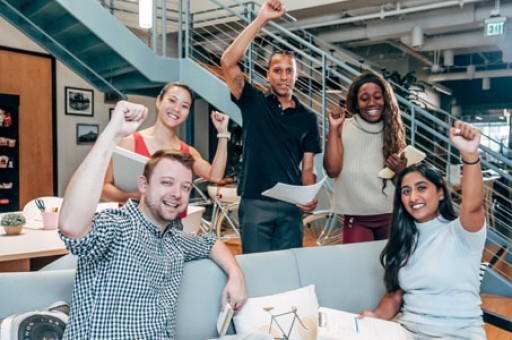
xmin=210 ymin=240 xmax=247 ymax=311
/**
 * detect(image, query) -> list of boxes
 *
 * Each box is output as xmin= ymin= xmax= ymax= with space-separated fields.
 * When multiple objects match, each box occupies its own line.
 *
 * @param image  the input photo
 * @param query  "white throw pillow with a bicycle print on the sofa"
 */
xmin=233 ymin=285 xmax=319 ymax=340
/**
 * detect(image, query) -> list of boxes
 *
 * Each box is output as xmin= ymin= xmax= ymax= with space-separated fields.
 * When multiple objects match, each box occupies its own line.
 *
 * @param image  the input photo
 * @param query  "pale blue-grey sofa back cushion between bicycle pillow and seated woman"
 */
xmin=294 ymin=241 xmax=386 ymax=313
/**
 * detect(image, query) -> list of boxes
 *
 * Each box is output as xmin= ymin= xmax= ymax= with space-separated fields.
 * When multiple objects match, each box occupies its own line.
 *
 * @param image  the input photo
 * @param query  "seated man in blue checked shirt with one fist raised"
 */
xmin=59 ymin=101 xmax=247 ymax=339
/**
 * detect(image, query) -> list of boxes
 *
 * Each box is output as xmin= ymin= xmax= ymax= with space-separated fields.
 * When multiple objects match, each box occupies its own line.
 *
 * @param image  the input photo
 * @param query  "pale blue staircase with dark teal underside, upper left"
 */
xmin=0 ymin=0 xmax=241 ymax=123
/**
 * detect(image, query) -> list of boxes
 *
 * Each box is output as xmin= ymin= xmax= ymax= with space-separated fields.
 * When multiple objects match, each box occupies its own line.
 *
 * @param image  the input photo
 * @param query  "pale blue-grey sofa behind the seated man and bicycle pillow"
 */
xmin=0 ymin=241 xmax=385 ymax=340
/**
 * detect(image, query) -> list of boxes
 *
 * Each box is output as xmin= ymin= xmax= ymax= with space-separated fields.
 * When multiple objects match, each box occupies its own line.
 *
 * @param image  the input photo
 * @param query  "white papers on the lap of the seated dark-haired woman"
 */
xmin=317 ymin=307 xmax=405 ymax=340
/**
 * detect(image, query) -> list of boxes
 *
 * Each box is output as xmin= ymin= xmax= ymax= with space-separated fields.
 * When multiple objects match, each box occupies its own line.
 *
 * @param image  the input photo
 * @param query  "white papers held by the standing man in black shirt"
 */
xmin=261 ymin=176 xmax=327 ymax=204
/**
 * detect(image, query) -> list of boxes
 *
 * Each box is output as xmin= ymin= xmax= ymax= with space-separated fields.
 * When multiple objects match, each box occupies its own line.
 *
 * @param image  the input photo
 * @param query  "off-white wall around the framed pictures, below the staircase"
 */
xmin=0 ymin=18 xmax=156 ymax=196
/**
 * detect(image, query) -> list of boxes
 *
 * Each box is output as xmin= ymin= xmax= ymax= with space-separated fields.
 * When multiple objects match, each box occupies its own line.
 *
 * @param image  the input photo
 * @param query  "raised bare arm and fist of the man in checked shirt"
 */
xmin=59 ymin=101 xmax=147 ymax=239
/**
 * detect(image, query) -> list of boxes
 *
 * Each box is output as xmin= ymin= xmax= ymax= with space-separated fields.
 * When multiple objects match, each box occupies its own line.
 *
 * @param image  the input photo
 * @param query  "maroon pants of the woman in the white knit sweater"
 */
xmin=343 ymin=214 xmax=391 ymax=243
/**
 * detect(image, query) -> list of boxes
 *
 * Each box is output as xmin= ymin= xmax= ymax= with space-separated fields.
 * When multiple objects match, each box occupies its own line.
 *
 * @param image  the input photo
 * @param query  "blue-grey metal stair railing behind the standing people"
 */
xmin=95 ymin=0 xmax=512 ymax=260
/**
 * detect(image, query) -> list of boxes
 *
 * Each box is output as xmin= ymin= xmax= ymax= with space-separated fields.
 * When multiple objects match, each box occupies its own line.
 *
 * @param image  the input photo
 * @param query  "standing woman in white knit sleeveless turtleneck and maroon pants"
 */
xmin=324 ymin=72 xmax=407 ymax=243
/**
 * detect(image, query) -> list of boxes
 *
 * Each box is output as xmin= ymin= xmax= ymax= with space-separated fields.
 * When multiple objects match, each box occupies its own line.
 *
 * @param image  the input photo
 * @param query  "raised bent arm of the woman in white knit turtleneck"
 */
xmin=324 ymin=107 xmax=345 ymax=178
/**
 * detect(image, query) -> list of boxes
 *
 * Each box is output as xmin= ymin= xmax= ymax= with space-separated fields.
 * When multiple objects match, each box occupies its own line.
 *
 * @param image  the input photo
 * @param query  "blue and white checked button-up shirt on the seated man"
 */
xmin=61 ymin=201 xmax=216 ymax=339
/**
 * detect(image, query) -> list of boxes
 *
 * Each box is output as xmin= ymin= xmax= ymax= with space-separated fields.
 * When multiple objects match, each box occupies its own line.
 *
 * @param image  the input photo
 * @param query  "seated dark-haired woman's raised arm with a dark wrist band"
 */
xmin=450 ymin=121 xmax=485 ymax=232
